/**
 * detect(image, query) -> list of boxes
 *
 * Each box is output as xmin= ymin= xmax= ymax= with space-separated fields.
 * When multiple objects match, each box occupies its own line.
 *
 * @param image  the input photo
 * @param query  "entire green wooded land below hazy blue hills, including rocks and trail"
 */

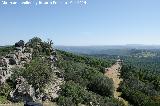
xmin=0 ymin=37 xmax=160 ymax=106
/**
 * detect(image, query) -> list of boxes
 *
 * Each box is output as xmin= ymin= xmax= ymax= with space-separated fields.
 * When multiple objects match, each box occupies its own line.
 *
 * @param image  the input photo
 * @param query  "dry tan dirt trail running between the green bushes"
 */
xmin=105 ymin=62 xmax=128 ymax=106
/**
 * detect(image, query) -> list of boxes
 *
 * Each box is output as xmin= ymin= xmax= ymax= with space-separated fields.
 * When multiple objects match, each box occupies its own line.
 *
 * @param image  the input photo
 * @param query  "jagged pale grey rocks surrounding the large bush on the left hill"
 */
xmin=0 ymin=40 xmax=64 ymax=102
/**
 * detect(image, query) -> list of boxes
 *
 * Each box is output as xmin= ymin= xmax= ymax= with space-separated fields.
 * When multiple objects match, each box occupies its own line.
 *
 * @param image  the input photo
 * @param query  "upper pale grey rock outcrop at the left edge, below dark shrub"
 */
xmin=0 ymin=40 xmax=32 ymax=85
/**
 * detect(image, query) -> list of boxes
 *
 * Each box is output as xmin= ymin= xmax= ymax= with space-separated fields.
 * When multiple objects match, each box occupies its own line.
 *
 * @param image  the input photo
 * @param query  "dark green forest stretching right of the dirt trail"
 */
xmin=89 ymin=49 xmax=160 ymax=106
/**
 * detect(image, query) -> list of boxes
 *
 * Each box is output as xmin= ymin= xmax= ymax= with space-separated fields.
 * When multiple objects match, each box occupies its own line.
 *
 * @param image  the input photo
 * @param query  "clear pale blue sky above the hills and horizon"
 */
xmin=0 ymin=0 xmax=160 ymax=46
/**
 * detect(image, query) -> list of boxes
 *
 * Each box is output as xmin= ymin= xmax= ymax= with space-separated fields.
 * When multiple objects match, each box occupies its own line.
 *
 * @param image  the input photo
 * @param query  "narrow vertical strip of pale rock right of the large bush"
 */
xmin=42 ymin=42 xmax=64 ymax=101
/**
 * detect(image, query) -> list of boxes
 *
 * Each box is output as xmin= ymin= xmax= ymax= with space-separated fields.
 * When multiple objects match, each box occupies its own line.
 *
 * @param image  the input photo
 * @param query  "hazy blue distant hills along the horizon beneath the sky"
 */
xmin=56 ymin=44 xmax=160 ymax=56
